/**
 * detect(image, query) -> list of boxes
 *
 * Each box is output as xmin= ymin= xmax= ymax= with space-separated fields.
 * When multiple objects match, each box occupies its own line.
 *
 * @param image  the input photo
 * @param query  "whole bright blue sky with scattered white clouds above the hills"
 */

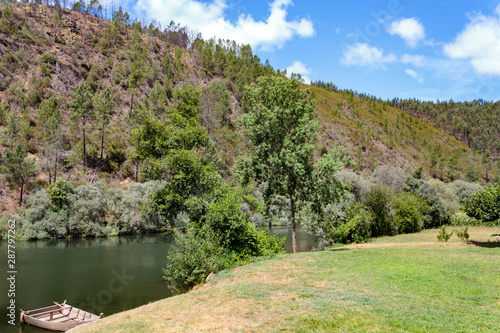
xmin=122 ymin=0 xmax=500 ymax=101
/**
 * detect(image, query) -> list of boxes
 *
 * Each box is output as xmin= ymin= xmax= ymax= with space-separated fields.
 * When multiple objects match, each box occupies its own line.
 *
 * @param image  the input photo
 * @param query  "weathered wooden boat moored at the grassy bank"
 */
xmin=21 ymin=301 xmax=103 ymax=332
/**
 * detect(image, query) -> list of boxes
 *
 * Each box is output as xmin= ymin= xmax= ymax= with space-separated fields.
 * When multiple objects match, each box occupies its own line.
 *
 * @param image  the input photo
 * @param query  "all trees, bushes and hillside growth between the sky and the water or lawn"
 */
xmin=0 ymin=1 xmax=500 ymax=291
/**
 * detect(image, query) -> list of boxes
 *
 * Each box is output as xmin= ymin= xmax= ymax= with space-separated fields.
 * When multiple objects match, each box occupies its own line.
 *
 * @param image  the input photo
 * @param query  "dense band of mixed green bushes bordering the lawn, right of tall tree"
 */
xmin=306 ymin=166 xmax=488 ymax=246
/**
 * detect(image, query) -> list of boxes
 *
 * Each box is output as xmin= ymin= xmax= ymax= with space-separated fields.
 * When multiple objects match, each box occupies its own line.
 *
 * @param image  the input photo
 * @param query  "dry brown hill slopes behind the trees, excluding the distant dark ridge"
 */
xmin=0 ymin=4 xmax=494 ymax=215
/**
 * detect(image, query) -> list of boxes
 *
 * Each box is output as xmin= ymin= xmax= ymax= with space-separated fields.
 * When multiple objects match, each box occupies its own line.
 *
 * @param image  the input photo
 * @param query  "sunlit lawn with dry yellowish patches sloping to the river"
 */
xmin=72 ymin=228 xmax=500 ymax=332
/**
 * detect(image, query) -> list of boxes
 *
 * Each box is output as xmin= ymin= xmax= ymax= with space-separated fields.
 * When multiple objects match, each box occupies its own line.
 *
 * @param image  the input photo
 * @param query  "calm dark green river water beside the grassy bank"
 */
xmin=0 ymin=227 xmax=317 ymax=333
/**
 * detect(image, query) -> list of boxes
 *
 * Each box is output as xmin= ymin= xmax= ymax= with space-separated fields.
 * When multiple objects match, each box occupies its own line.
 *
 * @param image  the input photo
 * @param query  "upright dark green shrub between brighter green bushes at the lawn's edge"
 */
xmin=364 ymin=185 xmax=394 ymax=237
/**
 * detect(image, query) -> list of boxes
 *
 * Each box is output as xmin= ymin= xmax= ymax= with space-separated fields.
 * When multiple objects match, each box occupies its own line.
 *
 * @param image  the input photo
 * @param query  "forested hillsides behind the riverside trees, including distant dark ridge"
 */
xmin=0 ymin=2 xmax=499 ymax=215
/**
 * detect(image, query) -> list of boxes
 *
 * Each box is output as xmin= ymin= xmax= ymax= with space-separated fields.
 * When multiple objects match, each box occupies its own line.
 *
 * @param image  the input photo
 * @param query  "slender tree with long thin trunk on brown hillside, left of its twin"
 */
xmin=69 ymin=82 xmax=94 ymax=168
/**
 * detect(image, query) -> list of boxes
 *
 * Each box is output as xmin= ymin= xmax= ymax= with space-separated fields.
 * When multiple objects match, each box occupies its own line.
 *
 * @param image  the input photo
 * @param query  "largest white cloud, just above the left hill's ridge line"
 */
xmin=136 ymin=0 xmax=315 ymax=51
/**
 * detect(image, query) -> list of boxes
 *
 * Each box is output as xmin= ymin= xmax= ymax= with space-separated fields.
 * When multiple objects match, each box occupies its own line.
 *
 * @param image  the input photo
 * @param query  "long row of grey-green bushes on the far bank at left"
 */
xmin=17 ymin=179 xmax=168 ymax=240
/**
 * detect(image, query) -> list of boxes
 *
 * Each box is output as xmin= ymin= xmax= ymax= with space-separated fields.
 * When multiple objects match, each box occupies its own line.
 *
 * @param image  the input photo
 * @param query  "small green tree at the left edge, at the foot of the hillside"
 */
xmin=0 ymin=145 xmax=38 ymax=206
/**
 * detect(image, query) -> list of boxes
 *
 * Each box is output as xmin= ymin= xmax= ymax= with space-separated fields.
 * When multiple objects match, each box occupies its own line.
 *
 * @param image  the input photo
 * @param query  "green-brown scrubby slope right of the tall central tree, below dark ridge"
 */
xmin=309 ymin=87 xmax=484 ymax=178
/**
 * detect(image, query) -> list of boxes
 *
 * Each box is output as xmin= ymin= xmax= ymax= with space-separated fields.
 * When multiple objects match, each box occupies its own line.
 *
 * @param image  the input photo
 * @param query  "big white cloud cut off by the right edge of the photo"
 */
xmin=443 ymin=5 xmax=500 ymax=75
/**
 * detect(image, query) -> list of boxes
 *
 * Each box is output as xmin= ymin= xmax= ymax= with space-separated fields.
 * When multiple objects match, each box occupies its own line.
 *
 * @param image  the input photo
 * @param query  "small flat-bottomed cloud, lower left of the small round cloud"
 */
xmin=340 ymin=43 xmax=396 ymax=67
